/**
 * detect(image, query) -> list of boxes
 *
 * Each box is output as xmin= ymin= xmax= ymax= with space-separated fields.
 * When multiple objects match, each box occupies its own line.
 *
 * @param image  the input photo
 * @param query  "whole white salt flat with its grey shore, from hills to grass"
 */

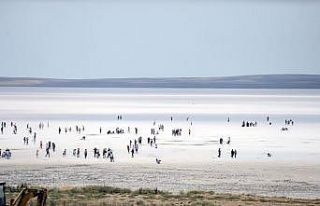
xmin=0 ymin=88 xmax=320 ymax=198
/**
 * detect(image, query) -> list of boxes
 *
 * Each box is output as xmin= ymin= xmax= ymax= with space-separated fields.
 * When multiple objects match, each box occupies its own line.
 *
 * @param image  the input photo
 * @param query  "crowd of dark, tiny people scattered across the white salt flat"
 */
xmin=0 ymin=115 xmax=294 ymax=164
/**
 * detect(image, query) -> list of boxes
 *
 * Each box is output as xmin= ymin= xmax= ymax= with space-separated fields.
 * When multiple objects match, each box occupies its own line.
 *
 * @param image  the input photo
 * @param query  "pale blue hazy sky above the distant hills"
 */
xmin=0 ymin=0 xmax=320 ymax=78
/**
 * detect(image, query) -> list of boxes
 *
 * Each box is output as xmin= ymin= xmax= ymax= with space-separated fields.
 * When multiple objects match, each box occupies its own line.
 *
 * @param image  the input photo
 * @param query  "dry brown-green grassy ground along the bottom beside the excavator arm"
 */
xmin=7 ymin=186 xmax=320 ymax=206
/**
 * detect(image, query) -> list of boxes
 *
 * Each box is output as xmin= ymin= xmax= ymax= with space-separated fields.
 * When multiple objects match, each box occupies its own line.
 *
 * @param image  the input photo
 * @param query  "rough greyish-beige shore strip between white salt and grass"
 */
xmin=0 ymin=162 xmax=320 ymax=199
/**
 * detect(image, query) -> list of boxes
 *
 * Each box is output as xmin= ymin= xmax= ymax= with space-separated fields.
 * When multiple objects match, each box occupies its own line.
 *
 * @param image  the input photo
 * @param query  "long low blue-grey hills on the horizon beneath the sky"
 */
xmin=0 ymin=74 xmax=320 ymax=89
